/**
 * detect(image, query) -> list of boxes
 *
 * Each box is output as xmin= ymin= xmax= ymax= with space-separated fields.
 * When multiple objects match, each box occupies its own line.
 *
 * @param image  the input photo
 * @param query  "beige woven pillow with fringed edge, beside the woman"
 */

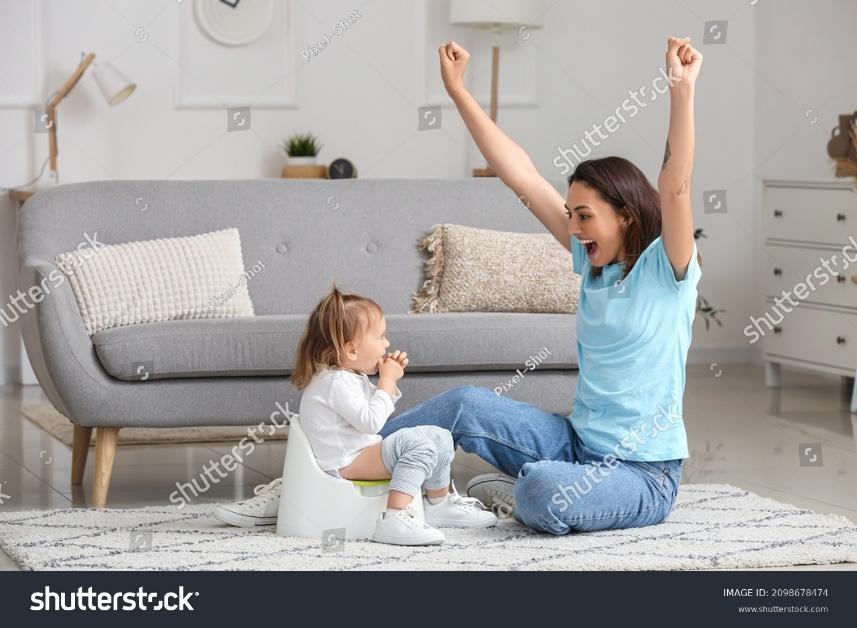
xmin=411 ymin=225 xmax=580 ymax=314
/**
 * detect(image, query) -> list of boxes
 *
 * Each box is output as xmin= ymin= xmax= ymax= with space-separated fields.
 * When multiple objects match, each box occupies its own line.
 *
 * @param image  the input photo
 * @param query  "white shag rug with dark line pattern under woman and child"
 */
xmin=0 ymin=484 xmax=857 ymax=571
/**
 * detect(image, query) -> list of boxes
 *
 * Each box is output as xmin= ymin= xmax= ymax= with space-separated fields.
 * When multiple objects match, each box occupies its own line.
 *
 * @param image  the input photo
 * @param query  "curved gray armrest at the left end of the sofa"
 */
xmin=18 ymin=257 xmax=109 ymax=425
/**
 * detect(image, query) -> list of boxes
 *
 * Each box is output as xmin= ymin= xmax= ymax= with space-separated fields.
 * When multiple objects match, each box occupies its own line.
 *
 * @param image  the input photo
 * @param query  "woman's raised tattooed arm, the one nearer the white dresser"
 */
xmin=658 ymin=37 xmax=702 ymax=281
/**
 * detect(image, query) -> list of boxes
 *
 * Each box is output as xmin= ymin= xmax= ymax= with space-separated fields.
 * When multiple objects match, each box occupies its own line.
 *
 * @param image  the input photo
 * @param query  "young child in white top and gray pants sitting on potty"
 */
xmin=215 ymin=286 xmax=497 ymax=545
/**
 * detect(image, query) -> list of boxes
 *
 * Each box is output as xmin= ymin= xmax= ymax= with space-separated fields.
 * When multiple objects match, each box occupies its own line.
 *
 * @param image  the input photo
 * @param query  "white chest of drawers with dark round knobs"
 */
xmin=764 ymin=180 xmax=857 ymax=400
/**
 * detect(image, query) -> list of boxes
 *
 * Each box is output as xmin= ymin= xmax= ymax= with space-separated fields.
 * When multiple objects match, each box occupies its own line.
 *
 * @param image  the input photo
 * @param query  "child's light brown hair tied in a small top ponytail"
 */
xmin=290 ymin=284 xmax=383 ymax=390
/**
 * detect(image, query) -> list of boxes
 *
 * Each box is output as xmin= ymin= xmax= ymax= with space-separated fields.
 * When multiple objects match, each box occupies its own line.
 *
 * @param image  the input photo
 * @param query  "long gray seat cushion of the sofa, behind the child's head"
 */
xmin=92 ymin=312 xmax=577 ymax=381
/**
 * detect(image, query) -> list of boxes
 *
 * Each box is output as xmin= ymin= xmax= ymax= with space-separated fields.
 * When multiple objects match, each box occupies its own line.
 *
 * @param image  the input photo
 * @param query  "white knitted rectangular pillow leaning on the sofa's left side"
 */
xmin=56 ymin=229 xmax=253 ymax=335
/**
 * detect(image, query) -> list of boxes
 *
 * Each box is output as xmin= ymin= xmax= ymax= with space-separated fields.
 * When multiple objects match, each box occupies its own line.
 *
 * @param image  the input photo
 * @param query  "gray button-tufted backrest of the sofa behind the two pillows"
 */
xmin=18 ymin=179 xmax=560 ymax=314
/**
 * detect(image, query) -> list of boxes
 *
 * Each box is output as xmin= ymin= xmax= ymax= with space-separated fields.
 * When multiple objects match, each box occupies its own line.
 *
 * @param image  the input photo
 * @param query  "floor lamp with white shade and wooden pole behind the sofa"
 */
xmin=449 ymin=0 xmax=544 ymax=177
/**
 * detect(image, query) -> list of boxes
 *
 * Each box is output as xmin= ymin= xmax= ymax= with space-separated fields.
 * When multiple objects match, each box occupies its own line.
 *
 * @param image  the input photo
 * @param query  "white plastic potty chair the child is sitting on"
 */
xmin=277 ymin=417 xmax=424 ymax=539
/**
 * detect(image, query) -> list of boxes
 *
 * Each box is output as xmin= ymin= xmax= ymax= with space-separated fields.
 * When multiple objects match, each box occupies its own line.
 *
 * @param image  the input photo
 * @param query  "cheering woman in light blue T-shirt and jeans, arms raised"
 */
xmin=381 ymin=37 xmax=702 ymax=534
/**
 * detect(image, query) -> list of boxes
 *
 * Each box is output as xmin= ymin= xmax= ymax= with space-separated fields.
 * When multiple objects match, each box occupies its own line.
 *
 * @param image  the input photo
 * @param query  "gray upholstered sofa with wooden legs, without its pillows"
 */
xmin=18 ymin=179 xmax=577 ymax=506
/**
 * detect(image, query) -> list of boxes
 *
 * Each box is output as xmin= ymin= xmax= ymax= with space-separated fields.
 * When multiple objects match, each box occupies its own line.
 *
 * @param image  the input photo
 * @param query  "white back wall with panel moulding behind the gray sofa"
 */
xmin=0 ymin=0 xmax=844 ymax=377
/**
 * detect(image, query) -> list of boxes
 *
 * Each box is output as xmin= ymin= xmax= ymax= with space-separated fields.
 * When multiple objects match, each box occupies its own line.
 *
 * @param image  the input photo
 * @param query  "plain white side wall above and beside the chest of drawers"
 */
xmin=752 ymin=0 xmax=857 ymax=362
